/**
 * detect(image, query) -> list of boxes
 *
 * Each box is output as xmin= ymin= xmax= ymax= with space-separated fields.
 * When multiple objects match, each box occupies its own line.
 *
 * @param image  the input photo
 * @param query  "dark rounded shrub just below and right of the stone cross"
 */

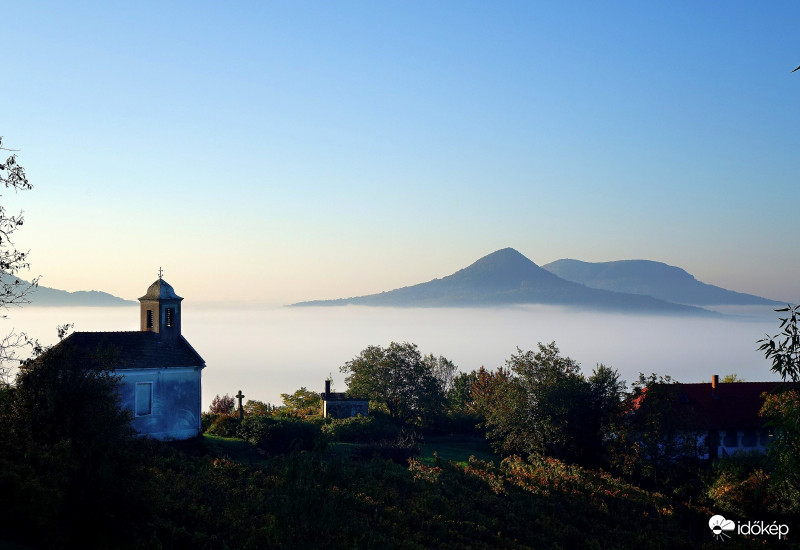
xmin=239 ymin=416 xmax=322 ymax=454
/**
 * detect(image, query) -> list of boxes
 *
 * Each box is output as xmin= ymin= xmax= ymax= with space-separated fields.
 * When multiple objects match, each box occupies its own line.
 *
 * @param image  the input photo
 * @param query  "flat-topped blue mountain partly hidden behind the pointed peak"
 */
xmin=542 ymin=260 xmax=785 ymax=306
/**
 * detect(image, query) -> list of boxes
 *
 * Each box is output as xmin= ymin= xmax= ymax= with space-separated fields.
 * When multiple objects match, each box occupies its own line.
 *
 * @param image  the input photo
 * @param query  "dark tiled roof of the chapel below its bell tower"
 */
xmin=59 ymin=332 xmax=206 ymax=369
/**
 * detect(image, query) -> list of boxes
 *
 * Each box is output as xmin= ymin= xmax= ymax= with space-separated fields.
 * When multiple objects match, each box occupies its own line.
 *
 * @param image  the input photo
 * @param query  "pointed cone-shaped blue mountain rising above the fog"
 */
xmin=292 ymin=248 xmax=711 ymax=315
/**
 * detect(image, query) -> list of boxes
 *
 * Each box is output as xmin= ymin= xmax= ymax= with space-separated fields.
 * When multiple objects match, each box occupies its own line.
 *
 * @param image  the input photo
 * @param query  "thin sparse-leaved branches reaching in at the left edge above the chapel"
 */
xmin=0 ymin=140 xmax=39 ymax=384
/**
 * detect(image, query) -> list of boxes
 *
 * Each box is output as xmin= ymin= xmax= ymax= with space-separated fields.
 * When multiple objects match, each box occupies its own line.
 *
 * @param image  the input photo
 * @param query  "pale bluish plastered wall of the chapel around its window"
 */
xmin=116 ymin=367 xmax=202 ymax=440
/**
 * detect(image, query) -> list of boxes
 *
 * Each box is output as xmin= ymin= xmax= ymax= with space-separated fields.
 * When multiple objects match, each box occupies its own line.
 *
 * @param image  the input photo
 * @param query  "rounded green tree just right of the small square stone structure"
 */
xmin=340 ymin=342 xmax=446 ymax=426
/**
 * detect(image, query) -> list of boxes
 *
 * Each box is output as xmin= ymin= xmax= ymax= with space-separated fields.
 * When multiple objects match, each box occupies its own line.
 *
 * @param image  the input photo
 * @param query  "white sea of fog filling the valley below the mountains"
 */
xmin=0 ymin=304 xmax=778 ymax=407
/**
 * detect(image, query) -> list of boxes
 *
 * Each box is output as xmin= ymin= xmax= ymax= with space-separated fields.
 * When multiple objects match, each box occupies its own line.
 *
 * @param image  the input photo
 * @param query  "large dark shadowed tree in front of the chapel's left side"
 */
xmin=0 ymin=332 xmax=149 ymax=548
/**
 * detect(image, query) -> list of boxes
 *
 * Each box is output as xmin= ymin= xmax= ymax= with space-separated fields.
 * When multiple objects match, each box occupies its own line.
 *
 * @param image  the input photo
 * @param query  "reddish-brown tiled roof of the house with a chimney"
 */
xmin=680 ymin=382 xmax=789 ymax=430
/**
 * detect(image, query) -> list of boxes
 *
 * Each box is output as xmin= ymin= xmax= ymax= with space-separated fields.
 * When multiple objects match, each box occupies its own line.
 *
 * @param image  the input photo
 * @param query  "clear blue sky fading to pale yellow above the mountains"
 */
xmin=0 ymin=0 xmax=800 ymax=305
